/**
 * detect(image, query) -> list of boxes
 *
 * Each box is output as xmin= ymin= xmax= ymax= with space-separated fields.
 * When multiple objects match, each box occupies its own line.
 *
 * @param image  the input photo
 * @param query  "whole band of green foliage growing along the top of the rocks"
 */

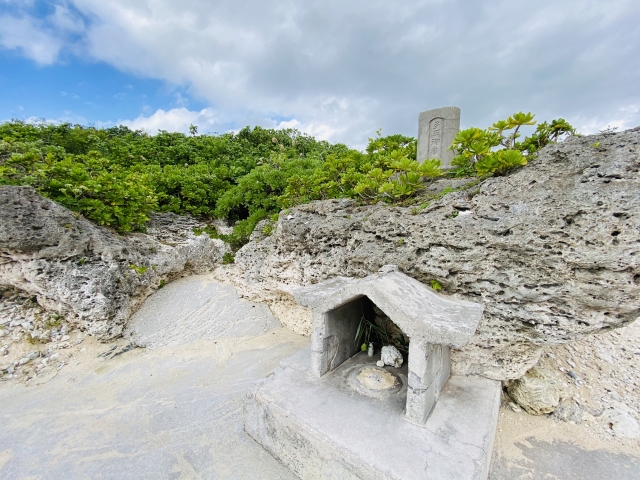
xmin=0 ymin=113 xmax=575 ymax=245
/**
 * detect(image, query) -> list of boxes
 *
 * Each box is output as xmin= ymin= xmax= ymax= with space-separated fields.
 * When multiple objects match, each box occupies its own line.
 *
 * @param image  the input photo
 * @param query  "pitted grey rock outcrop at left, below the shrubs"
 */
xmin=0 ymin=186 xmax=227 ymax=340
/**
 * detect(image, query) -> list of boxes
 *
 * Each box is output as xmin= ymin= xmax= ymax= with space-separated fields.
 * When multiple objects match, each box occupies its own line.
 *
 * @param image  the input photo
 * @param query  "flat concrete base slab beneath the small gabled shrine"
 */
xmin=245 ymin=348 xmax=501 ymax=480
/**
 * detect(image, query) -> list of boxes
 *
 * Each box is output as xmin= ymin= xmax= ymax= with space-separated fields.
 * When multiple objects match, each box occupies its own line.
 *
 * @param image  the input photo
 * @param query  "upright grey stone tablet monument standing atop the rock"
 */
xmin=418 ymin=107 xmax=460 ymax=169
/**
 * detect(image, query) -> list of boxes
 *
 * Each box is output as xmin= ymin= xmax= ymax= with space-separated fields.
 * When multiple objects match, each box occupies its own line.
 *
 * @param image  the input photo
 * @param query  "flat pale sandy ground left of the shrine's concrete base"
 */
xmin=0 ymin=327 xmax=307 ymax=480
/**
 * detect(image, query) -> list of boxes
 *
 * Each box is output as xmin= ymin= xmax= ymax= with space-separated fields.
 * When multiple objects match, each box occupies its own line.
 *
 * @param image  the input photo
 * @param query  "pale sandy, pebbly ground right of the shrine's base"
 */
xmin=490 ymin=321 xmax=640 ymax=480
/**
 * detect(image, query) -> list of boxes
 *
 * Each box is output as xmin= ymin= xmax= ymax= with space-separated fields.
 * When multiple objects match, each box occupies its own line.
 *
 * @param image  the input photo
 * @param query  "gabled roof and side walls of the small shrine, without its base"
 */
xmin=294 ymin=265 xmax=484 ymax=424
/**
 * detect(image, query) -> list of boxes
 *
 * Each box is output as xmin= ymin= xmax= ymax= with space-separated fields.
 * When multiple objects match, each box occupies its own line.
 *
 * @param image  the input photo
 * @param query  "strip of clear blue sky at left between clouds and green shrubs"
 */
xmin=0 ymin=50 xmax=205 ymax=125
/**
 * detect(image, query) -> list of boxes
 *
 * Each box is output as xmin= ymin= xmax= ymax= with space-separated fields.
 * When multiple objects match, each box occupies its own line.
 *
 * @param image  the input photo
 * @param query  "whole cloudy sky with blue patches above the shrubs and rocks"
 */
xmin=0 ymin=0 xmax=640 ymax=147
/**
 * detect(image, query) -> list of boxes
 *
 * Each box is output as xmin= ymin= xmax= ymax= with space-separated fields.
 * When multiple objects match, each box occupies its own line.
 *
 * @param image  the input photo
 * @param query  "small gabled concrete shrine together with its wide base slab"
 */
xmin=244 ymin=265 xmax=502 ymax=480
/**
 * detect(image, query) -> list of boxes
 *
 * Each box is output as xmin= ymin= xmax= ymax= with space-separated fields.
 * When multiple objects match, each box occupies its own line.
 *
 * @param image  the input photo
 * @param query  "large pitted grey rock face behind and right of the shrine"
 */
xmin=236 ymin=128 xmax=640 ymax=380
